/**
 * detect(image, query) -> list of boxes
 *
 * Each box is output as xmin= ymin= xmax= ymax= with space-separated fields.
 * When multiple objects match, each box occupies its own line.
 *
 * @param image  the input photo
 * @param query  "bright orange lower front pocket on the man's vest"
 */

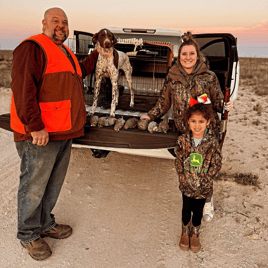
xmin=39 ymin=100 xmax=72 ymax=132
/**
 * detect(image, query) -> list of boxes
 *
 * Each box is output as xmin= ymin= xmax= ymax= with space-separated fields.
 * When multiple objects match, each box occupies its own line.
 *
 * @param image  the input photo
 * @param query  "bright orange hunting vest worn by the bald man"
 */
xmin=10 ymin=34 xmax=85 ymax=134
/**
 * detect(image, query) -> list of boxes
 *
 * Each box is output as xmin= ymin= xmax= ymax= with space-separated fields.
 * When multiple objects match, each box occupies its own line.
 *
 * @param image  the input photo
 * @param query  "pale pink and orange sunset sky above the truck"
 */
xmin=0 ymin=0 xmax=268 ymax=57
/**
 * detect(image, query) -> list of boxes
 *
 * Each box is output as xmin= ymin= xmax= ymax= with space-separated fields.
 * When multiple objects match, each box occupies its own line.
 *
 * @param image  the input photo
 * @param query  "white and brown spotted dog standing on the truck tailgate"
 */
xmin=89 ymin=29 xmax=134 ymax=117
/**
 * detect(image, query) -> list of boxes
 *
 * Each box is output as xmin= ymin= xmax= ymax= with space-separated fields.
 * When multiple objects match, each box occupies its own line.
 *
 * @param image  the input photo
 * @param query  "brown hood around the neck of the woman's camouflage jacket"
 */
xmin=168 ymin=57 xmax=209 ymax=86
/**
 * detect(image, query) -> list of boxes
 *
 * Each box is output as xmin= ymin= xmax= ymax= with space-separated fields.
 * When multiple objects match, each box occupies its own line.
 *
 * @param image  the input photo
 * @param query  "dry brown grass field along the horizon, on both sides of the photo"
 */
xmin=0 ymin=50 xmax=268 ymax=96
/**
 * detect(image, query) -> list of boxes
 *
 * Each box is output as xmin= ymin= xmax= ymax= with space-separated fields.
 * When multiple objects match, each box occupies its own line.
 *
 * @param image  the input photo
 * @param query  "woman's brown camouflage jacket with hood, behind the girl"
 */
xmin=148 ymin=60 xmax=223 ymax=134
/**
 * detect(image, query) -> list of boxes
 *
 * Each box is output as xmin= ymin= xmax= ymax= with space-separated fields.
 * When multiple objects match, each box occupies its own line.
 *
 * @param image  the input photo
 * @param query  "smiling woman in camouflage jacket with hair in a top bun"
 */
xmin=141 ymin=32 xmax=233 ymax=221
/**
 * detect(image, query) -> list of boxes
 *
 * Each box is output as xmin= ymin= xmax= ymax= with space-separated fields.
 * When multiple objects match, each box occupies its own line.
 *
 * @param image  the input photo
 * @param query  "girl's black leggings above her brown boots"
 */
xmin=182 ymin=194 xmax=206 ymax=227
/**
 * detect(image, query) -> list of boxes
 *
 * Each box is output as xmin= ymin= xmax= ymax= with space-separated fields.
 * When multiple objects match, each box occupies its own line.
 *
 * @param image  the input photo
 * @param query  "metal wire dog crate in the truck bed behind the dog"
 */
xmin=81 ymin=39 xmax=173 ymax=111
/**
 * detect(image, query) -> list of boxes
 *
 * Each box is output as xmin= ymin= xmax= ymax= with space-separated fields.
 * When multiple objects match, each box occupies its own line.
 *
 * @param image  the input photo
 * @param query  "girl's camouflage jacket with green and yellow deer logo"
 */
xmin=175 ymin=131 xmax=222 ymax=199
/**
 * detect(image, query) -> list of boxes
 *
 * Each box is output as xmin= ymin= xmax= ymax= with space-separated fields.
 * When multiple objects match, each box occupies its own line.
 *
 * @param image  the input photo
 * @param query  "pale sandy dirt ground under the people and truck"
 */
xmin=0 ymin=87 xmax=268 ymax=268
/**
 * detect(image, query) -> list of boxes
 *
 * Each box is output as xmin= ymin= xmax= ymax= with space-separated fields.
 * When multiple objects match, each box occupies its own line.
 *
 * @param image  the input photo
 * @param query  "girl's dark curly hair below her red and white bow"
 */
xmin=184 ymin=103 xmax=216 ymax=131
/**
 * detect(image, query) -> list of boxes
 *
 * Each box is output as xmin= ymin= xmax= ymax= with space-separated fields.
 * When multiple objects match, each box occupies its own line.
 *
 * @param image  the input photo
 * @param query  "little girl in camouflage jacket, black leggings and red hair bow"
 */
xmin=175 ymin=99 xmax=222 ymax=252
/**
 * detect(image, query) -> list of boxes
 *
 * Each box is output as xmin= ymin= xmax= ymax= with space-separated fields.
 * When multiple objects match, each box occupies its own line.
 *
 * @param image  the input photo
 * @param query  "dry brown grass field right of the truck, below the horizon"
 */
xmin=239 ymin=58 xmax=268 ymax=96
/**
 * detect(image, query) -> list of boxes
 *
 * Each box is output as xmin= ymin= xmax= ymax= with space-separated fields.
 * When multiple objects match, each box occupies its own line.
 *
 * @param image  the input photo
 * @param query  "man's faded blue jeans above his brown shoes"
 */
xmin=16 ymin=140 xmax=72 ymax=243
